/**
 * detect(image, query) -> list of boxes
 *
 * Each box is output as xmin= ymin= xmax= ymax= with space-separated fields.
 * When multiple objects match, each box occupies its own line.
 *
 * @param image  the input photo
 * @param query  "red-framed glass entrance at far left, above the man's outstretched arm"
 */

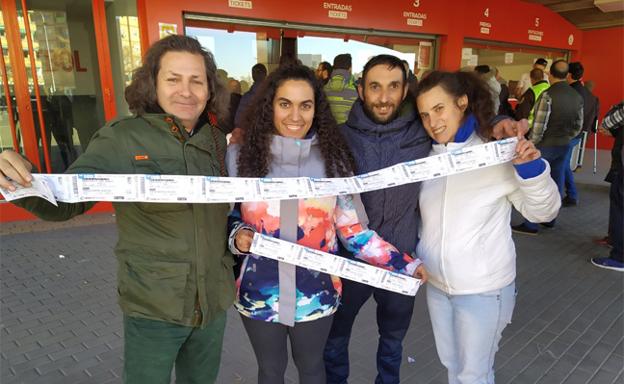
xmin=0 ymin=0 xmax=110 ymax=173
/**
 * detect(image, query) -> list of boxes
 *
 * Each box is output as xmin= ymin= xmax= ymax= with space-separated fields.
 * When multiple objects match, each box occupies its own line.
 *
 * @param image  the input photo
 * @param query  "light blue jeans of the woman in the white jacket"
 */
xmin=427 ymin=283 xmax=516 ymax=384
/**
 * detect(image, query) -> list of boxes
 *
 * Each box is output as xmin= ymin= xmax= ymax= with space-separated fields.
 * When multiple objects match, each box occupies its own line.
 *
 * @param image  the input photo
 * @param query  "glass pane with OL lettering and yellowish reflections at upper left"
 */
xmin=18 ymin=1 xmax=104 ymax=172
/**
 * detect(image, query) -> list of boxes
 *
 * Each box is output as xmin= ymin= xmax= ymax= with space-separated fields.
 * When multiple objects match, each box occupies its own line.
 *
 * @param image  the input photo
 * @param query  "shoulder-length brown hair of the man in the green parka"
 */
xmin=125 ymin=35 xmax=230 ymax=121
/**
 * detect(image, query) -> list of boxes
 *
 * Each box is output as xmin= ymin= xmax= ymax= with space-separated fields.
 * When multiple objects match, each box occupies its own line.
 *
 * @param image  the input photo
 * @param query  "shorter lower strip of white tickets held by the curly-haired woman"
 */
xmin=249 ymin=233 xmax=420 ymax=296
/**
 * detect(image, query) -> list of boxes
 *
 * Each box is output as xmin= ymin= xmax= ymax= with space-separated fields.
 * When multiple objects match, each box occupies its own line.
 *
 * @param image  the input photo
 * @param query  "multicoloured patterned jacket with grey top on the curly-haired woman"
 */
xmin=227 ymin=136 xmax=421 ymax=322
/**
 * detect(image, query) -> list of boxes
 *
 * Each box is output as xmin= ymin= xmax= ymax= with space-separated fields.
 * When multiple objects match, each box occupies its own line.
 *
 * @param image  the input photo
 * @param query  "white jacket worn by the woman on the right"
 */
xmin=416 ymin=132 xmax=561 ymax=295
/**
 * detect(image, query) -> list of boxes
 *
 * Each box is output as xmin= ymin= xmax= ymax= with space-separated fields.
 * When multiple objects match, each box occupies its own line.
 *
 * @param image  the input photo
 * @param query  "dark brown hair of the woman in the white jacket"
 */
xmin=415 ymin=71 xmax=494 ymax=141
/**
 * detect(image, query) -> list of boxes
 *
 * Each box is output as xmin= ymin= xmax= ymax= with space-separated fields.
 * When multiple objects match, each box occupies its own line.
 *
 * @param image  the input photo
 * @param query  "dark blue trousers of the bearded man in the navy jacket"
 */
xmin=325 ymin=279 xmax=414 ymax=384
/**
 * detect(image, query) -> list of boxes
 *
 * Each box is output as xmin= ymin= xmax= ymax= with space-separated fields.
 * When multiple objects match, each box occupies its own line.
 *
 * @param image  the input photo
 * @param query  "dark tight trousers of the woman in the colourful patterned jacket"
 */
xmin=241 ymin=315 xmax=333 ymax=384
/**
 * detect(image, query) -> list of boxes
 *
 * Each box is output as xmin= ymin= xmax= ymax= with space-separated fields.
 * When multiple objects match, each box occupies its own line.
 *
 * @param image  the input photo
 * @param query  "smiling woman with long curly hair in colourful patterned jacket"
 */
xmin=226 ymin=65 xmax=426 ymax=384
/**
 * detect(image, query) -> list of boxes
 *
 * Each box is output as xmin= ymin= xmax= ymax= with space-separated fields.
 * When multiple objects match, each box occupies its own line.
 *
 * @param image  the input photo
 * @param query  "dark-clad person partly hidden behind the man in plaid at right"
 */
xmin=562 ymin=61 xmax=598 ymax=207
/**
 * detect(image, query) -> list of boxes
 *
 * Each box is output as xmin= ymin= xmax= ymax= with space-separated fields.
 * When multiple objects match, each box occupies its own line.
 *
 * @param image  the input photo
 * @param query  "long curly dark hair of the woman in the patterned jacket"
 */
xmin=238 ymin=64 xmax=355 ymax=177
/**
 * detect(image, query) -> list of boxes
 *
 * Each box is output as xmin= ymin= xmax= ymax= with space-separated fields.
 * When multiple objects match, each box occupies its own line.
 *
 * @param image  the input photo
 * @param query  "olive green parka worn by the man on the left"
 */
xmin=16 ymin=114 xmax=239 ymax=326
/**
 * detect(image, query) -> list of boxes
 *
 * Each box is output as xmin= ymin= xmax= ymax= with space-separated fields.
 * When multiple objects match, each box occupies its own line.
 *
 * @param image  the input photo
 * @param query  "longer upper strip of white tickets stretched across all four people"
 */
xmin=0 ymin=138 xmax=517 ymax=205
